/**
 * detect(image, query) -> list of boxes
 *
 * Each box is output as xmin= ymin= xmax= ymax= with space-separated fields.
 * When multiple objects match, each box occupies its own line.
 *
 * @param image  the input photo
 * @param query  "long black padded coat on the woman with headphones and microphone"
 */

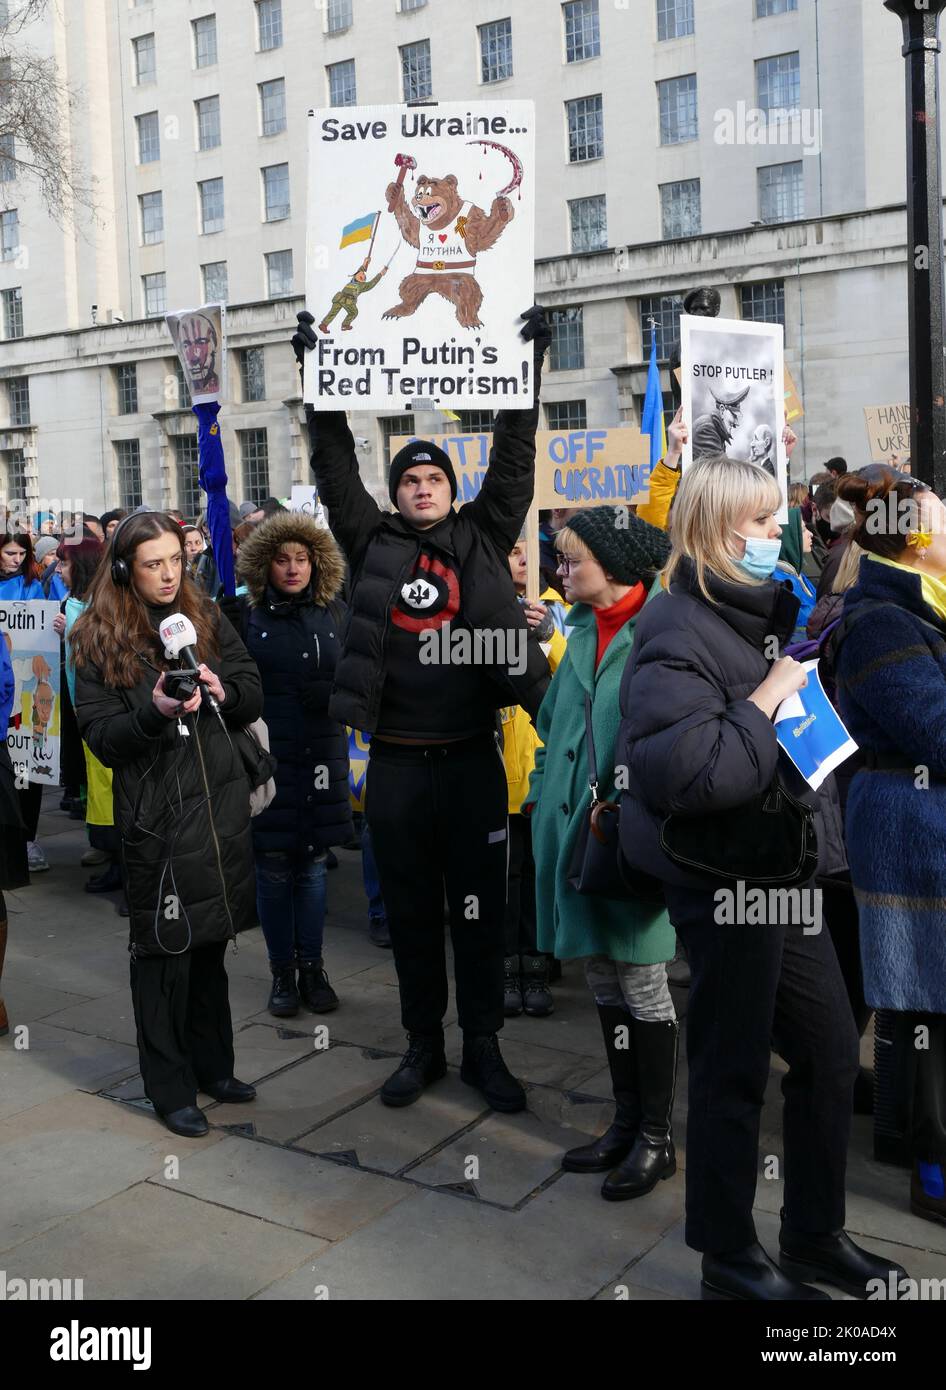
xmin=75 ymin=607 xmax=263 ymax=956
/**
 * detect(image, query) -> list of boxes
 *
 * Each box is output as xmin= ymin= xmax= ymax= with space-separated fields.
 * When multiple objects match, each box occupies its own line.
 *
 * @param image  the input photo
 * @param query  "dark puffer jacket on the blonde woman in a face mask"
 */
xmin=617 ymin=560 xmax=846 ymax=887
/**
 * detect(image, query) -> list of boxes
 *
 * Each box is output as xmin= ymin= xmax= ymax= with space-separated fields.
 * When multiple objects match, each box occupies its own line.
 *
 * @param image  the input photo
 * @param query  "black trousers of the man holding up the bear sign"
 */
xmin=365 ymin=733 xmax=508 ymax=1036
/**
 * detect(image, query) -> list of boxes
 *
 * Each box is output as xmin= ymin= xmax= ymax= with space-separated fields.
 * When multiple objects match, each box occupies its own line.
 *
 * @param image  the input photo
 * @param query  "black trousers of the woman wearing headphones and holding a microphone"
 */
xmin=132 ymin=941 xmax=233 ymax=1115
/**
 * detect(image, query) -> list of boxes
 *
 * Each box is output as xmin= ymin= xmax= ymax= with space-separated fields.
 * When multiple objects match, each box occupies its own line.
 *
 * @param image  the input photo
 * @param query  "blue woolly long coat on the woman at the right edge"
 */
xmin=836 ymin=557 xmax=946 ymax=1013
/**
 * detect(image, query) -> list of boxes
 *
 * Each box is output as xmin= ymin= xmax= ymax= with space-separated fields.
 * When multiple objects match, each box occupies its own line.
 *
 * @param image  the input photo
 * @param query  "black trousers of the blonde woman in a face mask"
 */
xmin=667 ymin=887 xmax=858 ymax=1254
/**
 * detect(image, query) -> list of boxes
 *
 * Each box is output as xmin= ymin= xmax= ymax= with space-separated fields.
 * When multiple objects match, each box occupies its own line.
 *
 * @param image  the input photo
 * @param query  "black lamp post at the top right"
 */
xmin=883 ymin=0 xmax=946 ymax=496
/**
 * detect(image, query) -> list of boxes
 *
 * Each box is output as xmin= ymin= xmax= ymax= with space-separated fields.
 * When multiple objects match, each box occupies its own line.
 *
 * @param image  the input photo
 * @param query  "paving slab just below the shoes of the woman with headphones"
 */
xmin=151 ymin=1138 xmax=411 ymax=1240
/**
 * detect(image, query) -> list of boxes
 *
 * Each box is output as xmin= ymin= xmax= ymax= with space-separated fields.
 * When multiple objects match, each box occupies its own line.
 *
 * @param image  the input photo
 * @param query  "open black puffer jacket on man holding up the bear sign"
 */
xmin=307 ymin=354 xmax=550 ymax=733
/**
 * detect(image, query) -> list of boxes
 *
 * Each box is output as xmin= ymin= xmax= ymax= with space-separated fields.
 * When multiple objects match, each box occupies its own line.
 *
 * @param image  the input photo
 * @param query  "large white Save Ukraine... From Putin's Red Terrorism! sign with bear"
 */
xmin=304 ymin=101 xmax=535 ymax=414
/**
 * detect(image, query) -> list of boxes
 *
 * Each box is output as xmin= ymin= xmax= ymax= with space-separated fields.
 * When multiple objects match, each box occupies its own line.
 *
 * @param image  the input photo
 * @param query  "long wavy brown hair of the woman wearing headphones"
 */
xmin=69 ymin=512 xmax=219 ymax=688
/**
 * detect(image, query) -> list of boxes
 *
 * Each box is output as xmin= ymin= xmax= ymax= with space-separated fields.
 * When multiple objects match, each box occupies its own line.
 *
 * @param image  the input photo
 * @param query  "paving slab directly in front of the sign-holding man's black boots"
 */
xmin=294 ymin=1070 xmax=486 ymax=1173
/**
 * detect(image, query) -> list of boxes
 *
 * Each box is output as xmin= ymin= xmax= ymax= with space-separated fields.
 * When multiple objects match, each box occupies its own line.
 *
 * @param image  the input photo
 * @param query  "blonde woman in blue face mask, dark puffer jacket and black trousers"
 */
xmin=617 ymin=456 xmax=902 ymax=1301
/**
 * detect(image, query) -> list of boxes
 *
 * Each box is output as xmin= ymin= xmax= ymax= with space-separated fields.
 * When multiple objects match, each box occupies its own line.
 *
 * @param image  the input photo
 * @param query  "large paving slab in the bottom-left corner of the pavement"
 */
xmin=4 ymin=1178 xmax=329 ymax=1301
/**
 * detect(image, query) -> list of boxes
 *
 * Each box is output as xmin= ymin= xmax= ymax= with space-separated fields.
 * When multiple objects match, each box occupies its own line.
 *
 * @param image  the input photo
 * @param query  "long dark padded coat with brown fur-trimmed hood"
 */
xmin=230 ymin=512 xmax=351 ymax=855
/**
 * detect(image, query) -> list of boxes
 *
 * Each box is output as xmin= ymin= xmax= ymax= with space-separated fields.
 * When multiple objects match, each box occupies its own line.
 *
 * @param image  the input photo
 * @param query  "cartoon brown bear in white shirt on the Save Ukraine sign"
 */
xmin=383 ymin=174 xmax=515 ymax=328
